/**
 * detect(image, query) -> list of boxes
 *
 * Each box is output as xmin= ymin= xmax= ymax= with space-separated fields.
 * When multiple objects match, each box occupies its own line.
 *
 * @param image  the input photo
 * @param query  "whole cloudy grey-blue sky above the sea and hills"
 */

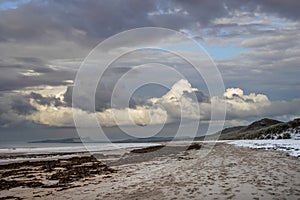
xmin=0 ymin=0 xmax=300 ymax=141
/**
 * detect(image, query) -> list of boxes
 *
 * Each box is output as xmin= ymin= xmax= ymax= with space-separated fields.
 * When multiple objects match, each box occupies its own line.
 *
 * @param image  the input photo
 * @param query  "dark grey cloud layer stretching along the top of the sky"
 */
xmin=0 ymin=0 xmax=300 ymax=44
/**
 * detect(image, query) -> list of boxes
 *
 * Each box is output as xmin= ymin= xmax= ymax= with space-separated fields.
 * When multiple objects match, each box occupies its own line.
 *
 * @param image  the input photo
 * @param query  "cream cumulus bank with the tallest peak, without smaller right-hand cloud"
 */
xmin=27 ymin=80 xmax=202 ymax=126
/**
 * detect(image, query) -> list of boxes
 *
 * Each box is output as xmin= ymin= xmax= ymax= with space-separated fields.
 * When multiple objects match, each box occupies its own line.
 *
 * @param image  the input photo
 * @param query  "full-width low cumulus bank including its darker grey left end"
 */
xmin=1 ymin=80 xmax=300 ymax=127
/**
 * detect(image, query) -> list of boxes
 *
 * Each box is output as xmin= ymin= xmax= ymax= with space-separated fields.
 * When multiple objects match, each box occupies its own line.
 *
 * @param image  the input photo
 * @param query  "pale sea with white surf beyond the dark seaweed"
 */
xmin=0 ymin=142 xmax=160 ymax=163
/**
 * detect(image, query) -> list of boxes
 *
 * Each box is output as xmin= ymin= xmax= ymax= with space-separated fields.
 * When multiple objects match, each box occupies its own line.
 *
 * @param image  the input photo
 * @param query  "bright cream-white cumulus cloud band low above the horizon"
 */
xmin=19 ymin=80 xmax=300 ymax=127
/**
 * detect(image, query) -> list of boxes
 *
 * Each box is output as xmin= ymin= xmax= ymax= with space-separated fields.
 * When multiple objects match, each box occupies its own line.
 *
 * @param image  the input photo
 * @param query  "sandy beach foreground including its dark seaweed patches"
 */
xmin=0 ymin=143 xmax=300 ymax=200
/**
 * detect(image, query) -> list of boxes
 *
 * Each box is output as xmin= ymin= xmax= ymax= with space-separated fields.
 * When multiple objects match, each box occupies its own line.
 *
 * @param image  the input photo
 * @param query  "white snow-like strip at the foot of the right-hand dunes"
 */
xmin=224 ymin=139 xmax=300 ymax=157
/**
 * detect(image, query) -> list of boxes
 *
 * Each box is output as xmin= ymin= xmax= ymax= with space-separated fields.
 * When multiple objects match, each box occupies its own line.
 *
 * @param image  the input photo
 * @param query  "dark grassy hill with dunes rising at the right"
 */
xmin=196 ymin=118 xmax=300 ymax=140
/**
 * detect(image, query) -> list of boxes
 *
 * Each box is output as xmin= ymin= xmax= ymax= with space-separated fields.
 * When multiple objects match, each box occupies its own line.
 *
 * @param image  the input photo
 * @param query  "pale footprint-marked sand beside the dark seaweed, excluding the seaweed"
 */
xmin=0 ymin=143 xmax=300 ymax=200
